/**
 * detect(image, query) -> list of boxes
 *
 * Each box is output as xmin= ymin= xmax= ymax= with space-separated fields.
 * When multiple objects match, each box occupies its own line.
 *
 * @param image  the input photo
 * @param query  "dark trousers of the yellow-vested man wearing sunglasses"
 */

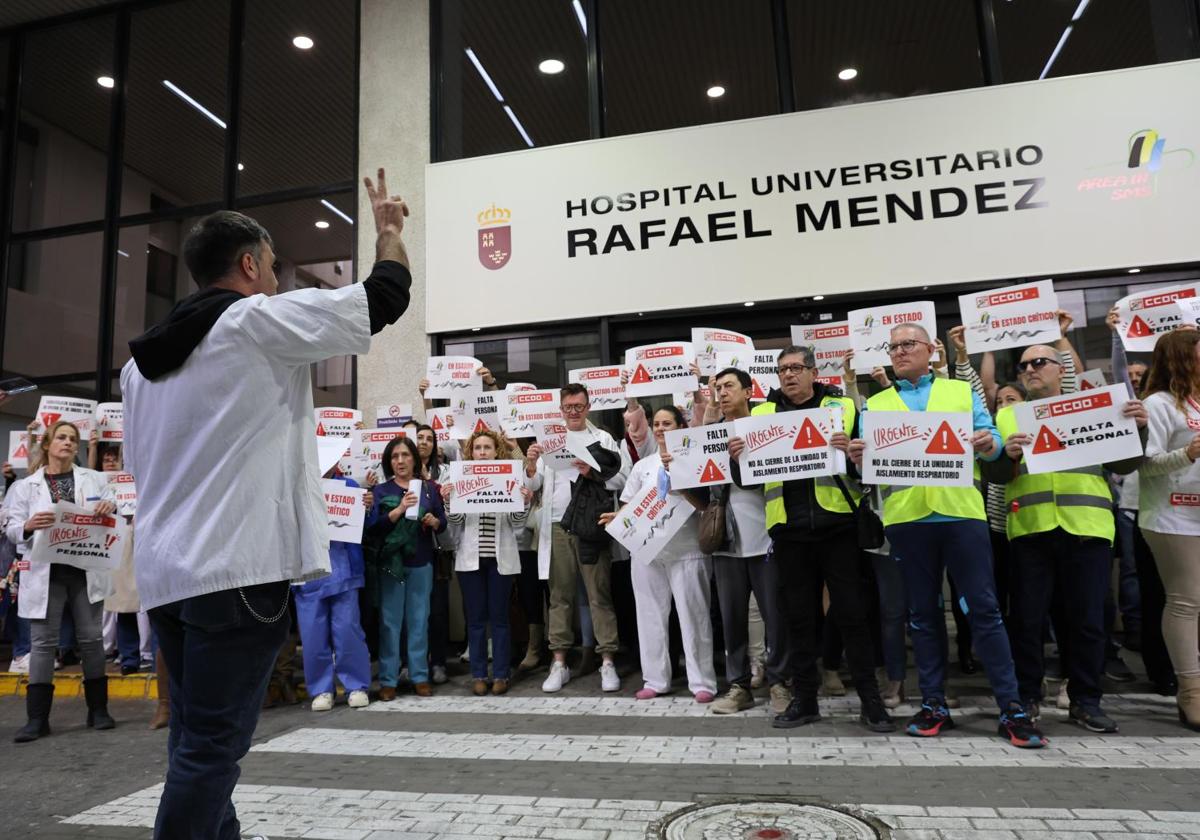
xmin=1010 ymin=528 xmax=1112 ymax=707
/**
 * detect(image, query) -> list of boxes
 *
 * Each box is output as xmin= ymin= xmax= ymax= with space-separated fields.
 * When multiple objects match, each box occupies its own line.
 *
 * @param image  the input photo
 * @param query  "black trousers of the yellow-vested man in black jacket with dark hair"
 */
xmin=773 ymin=528 xmax=880 ymax=701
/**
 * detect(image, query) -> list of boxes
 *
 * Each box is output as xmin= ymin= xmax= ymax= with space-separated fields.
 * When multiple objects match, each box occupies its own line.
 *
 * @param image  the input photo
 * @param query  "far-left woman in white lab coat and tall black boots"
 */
xmin=5 ymin=421 xmax=116 ymax=744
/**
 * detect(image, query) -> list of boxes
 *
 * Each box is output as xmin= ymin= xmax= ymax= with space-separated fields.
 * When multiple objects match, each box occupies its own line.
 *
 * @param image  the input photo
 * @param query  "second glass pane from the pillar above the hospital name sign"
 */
xmin=598 ymin=0 xmax=779 ymax=136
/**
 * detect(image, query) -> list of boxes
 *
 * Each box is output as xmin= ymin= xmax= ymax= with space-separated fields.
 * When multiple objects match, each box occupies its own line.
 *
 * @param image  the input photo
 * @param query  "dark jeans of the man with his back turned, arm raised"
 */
xmin=150 ymin=581 xmax=290 ymax=840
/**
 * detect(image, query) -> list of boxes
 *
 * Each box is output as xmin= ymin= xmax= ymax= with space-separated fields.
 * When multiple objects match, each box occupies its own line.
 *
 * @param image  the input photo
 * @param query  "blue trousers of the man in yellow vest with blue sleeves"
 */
xmin=887 ymin=520 xmax=1020 ymax=709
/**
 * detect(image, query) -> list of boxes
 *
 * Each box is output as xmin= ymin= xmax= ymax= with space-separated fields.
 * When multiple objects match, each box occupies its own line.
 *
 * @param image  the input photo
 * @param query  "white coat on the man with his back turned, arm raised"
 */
xmin=121 ymin=283 xmax=371 ymax=610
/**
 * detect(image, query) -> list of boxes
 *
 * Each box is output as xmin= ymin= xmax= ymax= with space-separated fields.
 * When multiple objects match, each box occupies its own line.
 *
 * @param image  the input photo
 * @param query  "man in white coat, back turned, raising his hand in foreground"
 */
xmin=121 ymin=169 xmax=412 ymax=840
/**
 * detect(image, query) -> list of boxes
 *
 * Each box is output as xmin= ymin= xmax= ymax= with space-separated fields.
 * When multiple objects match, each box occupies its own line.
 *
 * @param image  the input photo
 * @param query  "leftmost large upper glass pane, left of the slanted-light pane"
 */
xmin=13 ymin=16 xmax=114 ymax=230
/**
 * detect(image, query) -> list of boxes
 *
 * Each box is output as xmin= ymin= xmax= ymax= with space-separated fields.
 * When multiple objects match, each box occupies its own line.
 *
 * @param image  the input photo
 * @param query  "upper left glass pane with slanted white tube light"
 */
xmin=121 ymin=0 xmax=229 ymax=216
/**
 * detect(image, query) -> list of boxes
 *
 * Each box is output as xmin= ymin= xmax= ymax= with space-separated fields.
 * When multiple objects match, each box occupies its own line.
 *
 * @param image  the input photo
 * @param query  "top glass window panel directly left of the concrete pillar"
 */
xmin=238 ymin=0 xmax=352 ymax=196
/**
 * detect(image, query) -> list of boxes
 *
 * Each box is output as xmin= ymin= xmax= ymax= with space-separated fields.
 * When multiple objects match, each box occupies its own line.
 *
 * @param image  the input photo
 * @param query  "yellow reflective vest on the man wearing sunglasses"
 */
xmin=996 ymin=406 xmax=1116 ymax=542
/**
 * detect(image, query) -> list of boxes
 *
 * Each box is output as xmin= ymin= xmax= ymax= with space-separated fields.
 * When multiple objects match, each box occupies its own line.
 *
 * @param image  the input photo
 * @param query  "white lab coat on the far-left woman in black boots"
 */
xmin=4 ymin=467 xmax=115 ymax=619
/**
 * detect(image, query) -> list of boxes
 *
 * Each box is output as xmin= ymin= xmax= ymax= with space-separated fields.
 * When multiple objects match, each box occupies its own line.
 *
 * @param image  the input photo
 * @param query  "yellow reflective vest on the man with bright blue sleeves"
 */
xmin=866 ymin=377 xmax=988 ymax=527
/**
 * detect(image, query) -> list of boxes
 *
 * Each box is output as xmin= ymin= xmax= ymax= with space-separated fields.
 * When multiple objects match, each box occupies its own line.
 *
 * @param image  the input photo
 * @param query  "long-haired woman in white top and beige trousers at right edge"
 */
xmin=1138 ymin=330 xmax=1200 ymax=731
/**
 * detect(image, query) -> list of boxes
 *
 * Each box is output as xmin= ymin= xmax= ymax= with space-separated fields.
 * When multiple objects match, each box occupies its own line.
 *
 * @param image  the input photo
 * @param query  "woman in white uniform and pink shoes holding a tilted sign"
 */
xmin=600 ymin=406 xmax=716 ymax=703
